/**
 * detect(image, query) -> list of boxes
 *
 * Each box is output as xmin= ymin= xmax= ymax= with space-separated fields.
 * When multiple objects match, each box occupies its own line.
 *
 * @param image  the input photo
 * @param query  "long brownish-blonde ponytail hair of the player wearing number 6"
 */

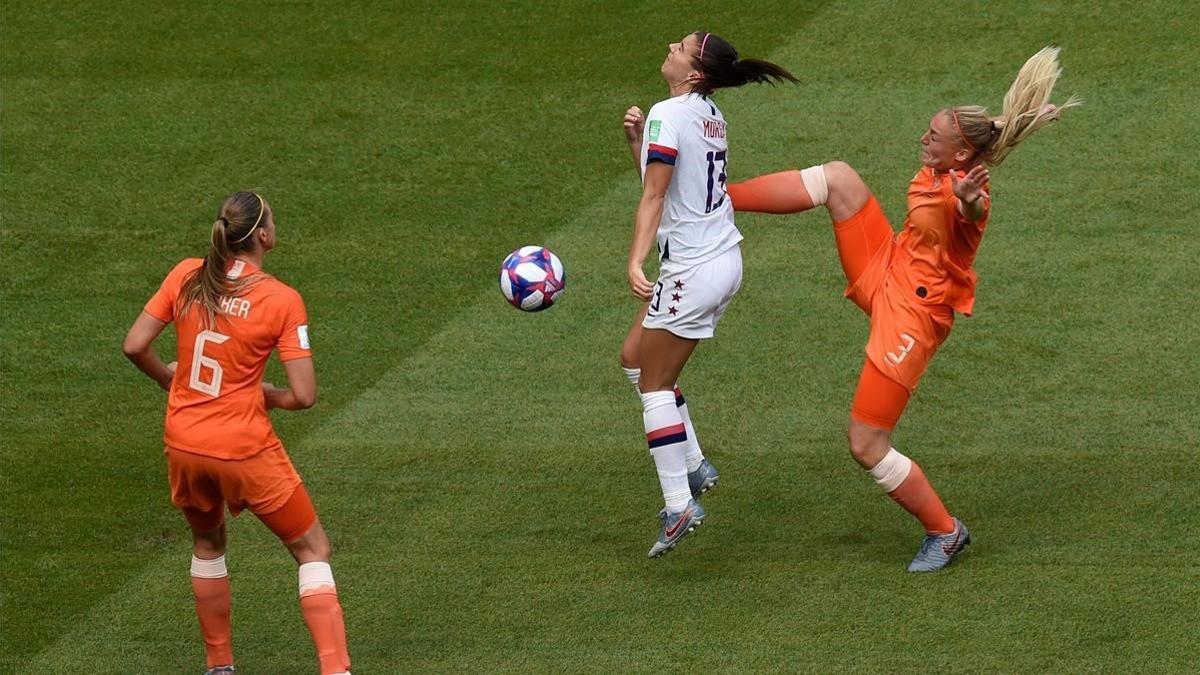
xmin=178 ymin=192 xmax=269 ymax=328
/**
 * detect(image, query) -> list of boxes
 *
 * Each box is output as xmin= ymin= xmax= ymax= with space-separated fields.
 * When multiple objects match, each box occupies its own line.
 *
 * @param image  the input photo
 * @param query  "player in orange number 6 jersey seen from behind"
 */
xmin=124 ymin=192 xmax=350 ymax=675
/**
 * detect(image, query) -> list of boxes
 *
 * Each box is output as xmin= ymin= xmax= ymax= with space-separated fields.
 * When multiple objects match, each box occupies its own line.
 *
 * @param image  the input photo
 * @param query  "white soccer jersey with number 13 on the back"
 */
xmin=642 ymin=94 xmax=742 ymax=264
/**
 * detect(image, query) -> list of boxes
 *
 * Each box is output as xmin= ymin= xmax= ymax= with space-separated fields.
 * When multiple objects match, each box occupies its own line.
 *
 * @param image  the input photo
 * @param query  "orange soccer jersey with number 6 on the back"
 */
xmin=145 ymin=258 xmax=312 ymax=460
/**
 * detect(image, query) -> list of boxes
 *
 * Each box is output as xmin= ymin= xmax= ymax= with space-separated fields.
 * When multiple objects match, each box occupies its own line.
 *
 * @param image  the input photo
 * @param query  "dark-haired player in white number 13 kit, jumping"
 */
xmin=620 ymin=32 xmax=796 ymax=557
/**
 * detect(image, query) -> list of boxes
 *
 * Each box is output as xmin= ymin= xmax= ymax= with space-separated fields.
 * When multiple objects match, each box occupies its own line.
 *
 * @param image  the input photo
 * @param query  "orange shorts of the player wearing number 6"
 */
xmin=164 ymin=446 xmax=317 ymax=542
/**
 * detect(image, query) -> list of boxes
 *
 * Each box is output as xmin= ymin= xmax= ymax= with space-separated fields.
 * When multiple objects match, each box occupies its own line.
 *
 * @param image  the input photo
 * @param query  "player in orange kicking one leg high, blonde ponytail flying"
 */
xmin=728 ymin=47 xmax=1079 ymax=572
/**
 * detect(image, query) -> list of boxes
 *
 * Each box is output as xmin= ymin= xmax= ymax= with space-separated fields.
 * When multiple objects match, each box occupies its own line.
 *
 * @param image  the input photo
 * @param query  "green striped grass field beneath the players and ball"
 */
xmin=0 ymin=0 xmax=1200 ymax=674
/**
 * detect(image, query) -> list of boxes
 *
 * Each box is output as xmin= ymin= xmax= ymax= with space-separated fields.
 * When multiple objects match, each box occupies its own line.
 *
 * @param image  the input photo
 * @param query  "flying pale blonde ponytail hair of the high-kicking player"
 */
xmin=947 ymin=47 xmax=1082 ymax=166
